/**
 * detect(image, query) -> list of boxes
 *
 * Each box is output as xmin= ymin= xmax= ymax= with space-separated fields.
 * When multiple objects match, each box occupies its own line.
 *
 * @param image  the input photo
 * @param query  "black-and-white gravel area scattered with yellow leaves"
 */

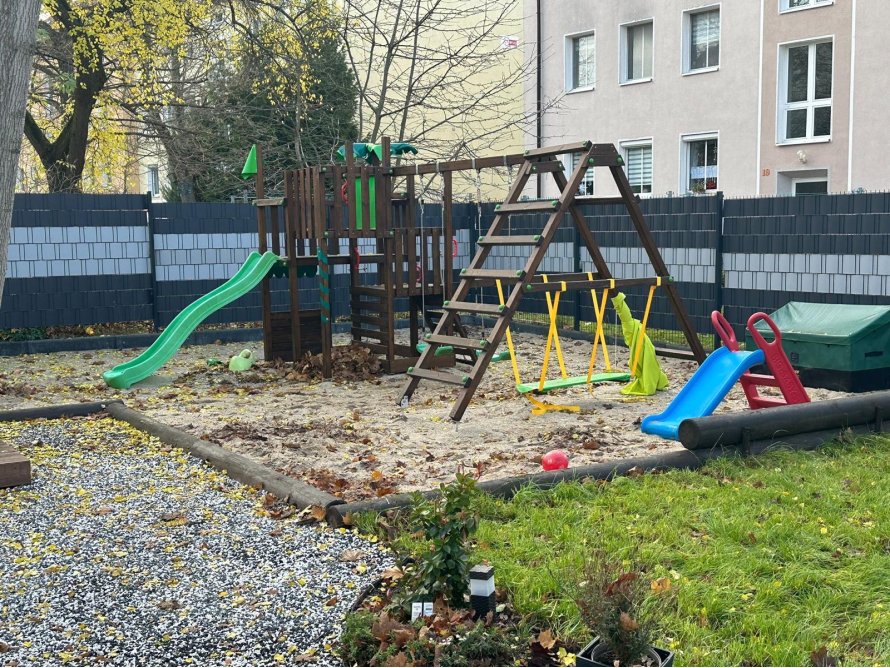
xmin=0 ymin=418 xmax=392 ymax=666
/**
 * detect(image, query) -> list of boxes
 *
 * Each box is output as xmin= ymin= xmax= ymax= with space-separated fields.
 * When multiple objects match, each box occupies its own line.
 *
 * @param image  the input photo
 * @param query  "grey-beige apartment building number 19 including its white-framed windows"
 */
xmin=524 ymin=0 xmax=890 ymax=197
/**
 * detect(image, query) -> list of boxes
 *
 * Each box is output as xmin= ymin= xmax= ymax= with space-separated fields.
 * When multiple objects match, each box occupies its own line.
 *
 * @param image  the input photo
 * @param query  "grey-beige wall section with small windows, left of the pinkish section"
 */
xmin=526 ymin=0 xmax=759 ymax=195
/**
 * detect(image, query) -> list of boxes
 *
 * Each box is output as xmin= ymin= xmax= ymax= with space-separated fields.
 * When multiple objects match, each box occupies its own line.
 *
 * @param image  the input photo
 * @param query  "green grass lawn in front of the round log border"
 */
xmin=366 ymin=437 xmax=890 ymax=666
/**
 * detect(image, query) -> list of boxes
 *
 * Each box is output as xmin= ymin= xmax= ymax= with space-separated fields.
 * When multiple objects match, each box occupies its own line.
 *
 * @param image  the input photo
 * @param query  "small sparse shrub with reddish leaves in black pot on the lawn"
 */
xmin=571 ymin=552 xmax=674 ymax=668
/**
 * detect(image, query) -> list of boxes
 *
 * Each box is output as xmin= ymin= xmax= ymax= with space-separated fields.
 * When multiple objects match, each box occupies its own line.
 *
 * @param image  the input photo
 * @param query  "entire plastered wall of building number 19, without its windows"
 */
xmin=524 ymin=0 xmax=890 ymax=196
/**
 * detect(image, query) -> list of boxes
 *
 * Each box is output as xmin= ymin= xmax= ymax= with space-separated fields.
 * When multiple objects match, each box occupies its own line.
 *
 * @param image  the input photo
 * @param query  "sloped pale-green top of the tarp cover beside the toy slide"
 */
xmin=749 ymin=302 xmax=890 ymax=346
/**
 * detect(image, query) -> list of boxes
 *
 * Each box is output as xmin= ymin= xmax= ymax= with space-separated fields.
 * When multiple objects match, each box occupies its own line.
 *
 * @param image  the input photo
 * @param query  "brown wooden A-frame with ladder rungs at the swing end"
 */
xmin=401 ymin=141 xmax=705 ymax=421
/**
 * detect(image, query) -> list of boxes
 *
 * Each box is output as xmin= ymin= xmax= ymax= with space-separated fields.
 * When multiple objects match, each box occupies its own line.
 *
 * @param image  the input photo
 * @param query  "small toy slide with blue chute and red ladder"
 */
xmin=642 ymin=311 xmax=810 ymax=440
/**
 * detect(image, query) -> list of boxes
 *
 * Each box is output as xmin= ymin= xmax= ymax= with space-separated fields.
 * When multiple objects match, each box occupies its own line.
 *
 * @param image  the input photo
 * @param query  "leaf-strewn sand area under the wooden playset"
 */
xmin=0 ymin=332 xmax=842 ymax=500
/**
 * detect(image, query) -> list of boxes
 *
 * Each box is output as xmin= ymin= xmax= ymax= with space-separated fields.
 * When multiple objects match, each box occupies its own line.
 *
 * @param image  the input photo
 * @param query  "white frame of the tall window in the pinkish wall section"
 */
xmin=776 ymin=35 xmax=837 ymax=146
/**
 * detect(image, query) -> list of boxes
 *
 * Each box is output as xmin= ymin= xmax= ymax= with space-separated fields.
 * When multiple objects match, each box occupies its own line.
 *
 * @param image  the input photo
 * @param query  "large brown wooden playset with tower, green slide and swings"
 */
xmin=103 ymin=137 xmax=705 ymax=396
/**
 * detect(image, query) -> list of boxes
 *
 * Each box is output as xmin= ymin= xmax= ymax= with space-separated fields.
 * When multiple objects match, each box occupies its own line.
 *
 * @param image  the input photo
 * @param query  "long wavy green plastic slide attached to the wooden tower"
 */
xmin=102 ymin=252 xmax=283 ymax=390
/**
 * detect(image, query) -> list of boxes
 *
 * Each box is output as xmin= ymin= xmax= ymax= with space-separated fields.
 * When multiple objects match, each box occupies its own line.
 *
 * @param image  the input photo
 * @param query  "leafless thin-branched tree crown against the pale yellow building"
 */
xmin=343 ymin=0 xmax=534 ymax=177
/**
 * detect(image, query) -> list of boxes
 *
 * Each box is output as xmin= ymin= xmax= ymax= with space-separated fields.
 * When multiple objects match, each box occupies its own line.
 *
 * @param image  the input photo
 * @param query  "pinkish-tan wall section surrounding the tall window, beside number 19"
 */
xmin=760 ymin=0 xmax=848 ymax=195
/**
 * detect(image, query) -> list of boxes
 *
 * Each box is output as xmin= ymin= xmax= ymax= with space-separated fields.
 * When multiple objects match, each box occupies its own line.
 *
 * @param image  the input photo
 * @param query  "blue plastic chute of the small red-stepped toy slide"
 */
xmin=642 ymin=348 xmax=764 ymax=441
